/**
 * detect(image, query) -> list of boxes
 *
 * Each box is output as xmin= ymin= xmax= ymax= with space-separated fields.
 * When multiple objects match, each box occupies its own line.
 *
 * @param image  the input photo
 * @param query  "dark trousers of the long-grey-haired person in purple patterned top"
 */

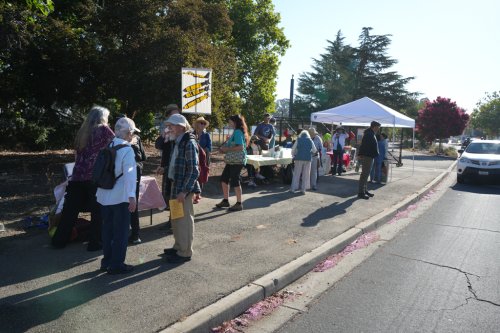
xmin=52 ymin=181 xmax=102 ymax=248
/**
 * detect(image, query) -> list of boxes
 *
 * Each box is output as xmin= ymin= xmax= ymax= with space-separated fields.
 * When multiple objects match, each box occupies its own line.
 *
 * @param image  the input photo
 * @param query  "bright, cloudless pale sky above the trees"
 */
xmin=273 ymin=0 xmax=500 ymax=112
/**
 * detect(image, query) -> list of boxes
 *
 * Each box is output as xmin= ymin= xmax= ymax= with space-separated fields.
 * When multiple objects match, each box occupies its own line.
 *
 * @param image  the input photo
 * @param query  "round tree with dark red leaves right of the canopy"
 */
xmin=416 ymin=97 xmax=470 ymax=142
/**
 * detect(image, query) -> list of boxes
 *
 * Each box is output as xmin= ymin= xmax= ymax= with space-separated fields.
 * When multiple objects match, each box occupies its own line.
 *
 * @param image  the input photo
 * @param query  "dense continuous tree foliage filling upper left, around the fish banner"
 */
xmin=0 ymin=0 xmax=288 ymax=149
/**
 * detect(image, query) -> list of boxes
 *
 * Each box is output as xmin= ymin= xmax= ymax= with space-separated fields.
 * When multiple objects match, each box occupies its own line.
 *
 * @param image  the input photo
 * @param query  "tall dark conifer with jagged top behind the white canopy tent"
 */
xmin=295 ymin=28 xmax=418 ymax=114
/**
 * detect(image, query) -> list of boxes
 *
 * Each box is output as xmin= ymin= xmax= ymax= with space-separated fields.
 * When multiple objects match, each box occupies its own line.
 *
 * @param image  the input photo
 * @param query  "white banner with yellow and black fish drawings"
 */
xmin=181 ymin=68 xmax=212 ymax=114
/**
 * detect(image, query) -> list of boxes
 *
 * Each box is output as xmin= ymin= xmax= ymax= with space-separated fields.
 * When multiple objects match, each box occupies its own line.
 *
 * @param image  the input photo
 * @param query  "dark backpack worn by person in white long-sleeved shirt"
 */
xmin=92 ymin=144 xmax=128 ymax=190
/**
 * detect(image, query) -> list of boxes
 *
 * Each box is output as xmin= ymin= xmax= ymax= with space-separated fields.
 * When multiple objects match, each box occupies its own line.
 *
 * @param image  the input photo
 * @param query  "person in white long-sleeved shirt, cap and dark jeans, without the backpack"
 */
xmin=96 ymin=117 xmax=139 ymax=274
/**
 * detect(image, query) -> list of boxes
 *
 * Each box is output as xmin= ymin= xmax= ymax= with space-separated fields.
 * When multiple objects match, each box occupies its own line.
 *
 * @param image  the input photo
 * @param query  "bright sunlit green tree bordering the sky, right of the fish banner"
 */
xmin=227 ymin=0 xmax=289 ymax=124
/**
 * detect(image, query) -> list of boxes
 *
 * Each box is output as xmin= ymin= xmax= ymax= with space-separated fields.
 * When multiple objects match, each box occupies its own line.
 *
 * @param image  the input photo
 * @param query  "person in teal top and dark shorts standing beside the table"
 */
xmin=215 ymin=115 xmax=249 ymax=211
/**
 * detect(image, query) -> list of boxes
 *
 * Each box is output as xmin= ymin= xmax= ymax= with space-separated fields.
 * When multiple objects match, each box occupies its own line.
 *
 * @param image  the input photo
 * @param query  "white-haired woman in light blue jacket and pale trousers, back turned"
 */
xmin=290 ymin=130 xmax=317 ymax=194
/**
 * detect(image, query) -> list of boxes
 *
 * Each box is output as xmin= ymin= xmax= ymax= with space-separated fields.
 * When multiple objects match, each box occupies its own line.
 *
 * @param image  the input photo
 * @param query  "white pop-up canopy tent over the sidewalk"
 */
xmin=311 ymin=97 xmax=415 ymax=176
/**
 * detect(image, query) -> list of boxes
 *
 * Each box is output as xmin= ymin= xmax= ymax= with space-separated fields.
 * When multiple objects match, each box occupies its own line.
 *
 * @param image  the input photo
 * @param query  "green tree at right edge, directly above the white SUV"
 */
xmin=471 ymin=91 xmax=500 ymax=138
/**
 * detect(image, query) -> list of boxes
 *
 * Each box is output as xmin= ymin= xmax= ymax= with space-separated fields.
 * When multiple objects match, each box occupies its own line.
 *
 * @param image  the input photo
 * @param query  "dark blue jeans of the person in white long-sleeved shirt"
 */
xmin=101 ymin=202 xmax=130 ymax=269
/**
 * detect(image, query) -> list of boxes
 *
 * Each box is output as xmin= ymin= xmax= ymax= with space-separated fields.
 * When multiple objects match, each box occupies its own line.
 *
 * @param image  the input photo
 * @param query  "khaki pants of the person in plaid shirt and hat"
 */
xmin=172 ymin=193 xmax=194 ymax=257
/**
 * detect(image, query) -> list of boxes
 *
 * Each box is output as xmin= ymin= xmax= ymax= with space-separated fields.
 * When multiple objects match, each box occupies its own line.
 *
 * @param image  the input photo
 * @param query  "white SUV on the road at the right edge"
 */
xmin=457 ymin=140 xmax=500 ymax=183
